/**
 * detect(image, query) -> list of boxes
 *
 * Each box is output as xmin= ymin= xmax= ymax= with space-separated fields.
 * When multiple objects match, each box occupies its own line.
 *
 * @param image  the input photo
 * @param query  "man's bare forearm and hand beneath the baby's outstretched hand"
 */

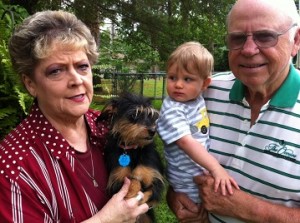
xmin=194 ymin=175 xmax=300 ymax=223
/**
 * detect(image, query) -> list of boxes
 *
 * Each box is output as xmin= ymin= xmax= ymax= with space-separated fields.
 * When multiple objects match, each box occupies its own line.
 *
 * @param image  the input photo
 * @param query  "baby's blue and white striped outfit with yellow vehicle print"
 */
xmin=157 ymin=96 xmax=209 ymax=203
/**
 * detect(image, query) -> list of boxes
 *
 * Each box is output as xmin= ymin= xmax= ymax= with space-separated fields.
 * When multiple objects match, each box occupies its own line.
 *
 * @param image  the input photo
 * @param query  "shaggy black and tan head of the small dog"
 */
xmin=100 ymin=93 xmax=159 ymax=147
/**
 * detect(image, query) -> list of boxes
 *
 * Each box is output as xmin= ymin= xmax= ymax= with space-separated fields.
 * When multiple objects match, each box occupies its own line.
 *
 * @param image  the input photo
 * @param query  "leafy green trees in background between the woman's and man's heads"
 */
xmin=7 ymin=0 xmax=235 ymax=70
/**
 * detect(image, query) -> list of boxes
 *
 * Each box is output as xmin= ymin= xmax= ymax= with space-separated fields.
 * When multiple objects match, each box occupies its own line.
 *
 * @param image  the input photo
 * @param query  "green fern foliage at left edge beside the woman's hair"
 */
xmin=0 ymin=2 xmax=32 ymax=139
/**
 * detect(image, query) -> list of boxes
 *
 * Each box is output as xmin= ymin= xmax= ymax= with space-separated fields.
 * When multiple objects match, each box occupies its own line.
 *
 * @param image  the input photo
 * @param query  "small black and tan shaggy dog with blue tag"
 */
xmin=99 ymin=93 xmax=164 ymax=223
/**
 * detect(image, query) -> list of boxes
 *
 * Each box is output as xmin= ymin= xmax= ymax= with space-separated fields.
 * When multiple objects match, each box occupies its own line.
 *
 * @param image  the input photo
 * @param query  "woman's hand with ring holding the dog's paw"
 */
xmin=84 ymin=178 xmax=149 ymax=223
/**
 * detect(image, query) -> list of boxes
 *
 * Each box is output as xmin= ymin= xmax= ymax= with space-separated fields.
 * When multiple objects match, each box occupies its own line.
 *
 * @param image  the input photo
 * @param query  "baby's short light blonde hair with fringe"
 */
xmin=167 ymin=41 xmax=214 ymax=79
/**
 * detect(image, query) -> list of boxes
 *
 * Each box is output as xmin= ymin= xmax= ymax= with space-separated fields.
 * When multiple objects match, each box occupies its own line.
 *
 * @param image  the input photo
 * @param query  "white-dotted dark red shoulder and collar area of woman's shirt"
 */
xmin=0 ymin=105 xmax=108 ymax=178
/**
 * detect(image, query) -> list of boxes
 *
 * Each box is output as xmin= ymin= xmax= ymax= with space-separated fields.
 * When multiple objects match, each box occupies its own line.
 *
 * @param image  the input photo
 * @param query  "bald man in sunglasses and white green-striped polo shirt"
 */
xmin=168 ymin=0 xmax=300 ymax=223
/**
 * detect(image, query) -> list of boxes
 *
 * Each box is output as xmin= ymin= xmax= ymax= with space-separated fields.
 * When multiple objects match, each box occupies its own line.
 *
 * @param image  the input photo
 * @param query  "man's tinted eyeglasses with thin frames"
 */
xmin=226 ymin=23 xmax=297 ymax=50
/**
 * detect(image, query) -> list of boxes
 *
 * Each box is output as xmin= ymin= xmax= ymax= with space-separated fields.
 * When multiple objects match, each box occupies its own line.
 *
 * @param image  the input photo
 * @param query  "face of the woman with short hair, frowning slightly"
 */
xmin=23 ymin=45 xmax=93 ymax=120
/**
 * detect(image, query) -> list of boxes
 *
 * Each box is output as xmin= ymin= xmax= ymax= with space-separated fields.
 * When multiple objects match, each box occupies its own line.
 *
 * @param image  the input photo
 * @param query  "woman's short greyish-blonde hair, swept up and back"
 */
xmin=9 ymin=11 xmax=98 ymax=80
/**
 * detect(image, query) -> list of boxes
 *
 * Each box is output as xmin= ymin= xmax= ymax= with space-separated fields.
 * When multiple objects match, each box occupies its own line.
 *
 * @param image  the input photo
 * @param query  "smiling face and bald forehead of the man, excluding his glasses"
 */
xmin=228 ymin=0 xmax=295 ymax=92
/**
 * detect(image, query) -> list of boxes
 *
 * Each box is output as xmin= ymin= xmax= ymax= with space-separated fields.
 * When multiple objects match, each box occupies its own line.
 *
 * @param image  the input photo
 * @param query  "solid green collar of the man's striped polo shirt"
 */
xmin=229 ymin=64 xmax=300 ymax=108
